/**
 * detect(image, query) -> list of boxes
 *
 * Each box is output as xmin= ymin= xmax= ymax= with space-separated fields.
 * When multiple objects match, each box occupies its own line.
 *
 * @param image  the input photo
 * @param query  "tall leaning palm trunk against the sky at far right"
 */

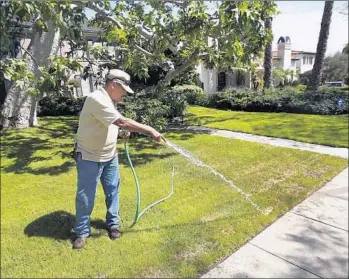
xmin=309 ymin=1 xmax=334 ymax=90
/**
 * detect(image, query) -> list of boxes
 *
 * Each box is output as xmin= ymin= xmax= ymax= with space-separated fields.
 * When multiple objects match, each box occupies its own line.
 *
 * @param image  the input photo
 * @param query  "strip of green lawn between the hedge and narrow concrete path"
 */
xmin=186 ymin=106 xmax=348 ymax=147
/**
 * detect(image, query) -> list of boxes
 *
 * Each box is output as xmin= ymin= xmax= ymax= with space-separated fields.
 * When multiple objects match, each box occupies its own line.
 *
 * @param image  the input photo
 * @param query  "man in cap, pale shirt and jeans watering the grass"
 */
xmin=73 ymin=69 xmax=161 ymax=249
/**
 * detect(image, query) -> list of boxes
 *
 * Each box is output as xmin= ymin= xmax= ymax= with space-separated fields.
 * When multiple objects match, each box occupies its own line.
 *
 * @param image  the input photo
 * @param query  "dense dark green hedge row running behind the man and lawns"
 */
xmin=38 ymin=85 xmax=349 ymax=130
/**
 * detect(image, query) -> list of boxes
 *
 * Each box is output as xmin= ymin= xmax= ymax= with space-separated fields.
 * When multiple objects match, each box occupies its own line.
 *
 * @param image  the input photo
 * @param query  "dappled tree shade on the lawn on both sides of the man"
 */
xmin=1 ymin=117 xmax=195 ymax=175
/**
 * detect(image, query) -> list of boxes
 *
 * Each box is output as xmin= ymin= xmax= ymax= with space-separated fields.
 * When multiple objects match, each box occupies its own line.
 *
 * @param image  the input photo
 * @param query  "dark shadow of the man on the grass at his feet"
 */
xmin=24 ymin=210 xmax=107 ymax=240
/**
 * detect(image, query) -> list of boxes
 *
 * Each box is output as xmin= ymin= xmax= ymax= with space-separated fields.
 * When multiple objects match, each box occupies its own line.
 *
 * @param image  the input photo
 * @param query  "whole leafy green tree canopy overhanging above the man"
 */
xmin=0 ymin=0 xmax=276 ymax=130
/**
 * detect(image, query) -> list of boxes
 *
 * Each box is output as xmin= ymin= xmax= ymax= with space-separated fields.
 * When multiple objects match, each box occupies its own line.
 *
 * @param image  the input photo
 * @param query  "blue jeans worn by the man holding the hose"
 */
xmin=74 ymin=153 xmax=120 ymax=237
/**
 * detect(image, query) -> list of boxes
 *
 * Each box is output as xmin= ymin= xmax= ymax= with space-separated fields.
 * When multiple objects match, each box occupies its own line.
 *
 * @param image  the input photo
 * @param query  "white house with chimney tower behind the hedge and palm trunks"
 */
xmin=197 ymin=36 xmax=316 ymax=93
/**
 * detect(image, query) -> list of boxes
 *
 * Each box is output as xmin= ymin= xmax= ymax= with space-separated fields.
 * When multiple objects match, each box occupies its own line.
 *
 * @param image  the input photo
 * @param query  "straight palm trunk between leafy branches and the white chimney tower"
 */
xmin=263 ymin=13 xmax=273 ymax=89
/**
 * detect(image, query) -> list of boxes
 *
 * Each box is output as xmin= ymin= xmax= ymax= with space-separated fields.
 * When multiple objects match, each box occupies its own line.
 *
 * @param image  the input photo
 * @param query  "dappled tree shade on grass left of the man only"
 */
xmin=1 ymin=117 xmax=77 ymax=175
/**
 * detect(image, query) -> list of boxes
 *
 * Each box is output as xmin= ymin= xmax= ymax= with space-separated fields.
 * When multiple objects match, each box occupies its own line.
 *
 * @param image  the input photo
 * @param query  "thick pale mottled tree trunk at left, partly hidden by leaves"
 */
xmin=0 ymin=22 xmax=59 ymax=129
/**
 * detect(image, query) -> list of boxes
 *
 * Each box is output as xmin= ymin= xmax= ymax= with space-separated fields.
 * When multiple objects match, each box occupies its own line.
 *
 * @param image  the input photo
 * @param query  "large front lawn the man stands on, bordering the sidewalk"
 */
xmin=1 ymin=117 xmax=347 ymax=278
